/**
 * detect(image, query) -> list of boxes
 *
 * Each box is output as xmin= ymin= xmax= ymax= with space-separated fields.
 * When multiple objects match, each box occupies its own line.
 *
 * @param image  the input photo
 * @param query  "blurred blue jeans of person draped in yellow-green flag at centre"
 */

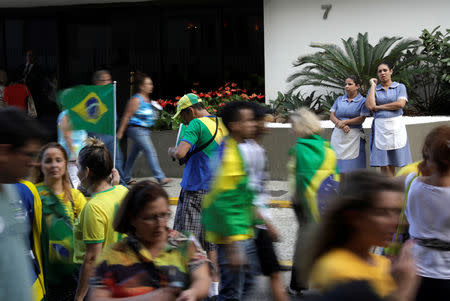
xmin=217 ymin=239 xmax=259 ymax=301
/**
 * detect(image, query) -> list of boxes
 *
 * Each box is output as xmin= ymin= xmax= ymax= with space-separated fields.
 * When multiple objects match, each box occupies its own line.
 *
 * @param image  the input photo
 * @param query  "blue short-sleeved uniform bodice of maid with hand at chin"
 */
xmin=369 ymin=82 xmax=408 ymax=118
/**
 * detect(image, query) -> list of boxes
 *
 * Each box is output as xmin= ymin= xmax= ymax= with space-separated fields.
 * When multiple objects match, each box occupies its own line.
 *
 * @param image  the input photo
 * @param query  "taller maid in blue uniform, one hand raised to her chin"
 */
xmin=366 ymin=63 xmax=412 ymax=176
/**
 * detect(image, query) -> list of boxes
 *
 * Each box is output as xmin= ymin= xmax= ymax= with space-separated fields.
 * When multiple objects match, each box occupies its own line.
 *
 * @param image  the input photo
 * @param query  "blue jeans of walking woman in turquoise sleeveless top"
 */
xmin=125 ymin=126 xmax=166 ymax=182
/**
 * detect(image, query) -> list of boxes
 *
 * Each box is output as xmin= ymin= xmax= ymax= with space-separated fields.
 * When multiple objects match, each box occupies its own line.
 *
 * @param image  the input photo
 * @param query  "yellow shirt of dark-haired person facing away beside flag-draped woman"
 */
xmin=73 ymin=185 xmax=128 ymax=264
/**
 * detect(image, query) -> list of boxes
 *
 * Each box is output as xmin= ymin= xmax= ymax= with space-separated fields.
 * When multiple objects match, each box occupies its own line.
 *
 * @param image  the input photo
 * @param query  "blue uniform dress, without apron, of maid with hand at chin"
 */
xmin=369 ymin=82 xmax=412 ymax=166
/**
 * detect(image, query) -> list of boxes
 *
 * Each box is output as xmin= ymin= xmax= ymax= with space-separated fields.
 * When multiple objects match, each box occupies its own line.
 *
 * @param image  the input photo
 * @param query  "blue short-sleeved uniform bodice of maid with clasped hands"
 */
xmin=330 ymin=93 xmax=370 ymax=128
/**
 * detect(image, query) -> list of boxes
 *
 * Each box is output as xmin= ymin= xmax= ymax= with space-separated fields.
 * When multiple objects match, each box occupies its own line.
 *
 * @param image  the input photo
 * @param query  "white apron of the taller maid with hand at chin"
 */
xmin=374 ymin=116 xmax=408 ymax=150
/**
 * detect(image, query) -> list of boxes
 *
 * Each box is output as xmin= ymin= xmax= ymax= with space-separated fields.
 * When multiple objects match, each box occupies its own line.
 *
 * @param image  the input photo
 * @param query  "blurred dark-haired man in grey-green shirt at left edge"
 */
xmin=0 ymin=107 xmax=44 ymax=301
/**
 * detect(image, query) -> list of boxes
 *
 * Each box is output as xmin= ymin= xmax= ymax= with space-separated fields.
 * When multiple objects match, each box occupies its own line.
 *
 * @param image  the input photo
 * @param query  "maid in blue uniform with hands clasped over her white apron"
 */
xmin=330 ymin=76 xmax=370 ymax=173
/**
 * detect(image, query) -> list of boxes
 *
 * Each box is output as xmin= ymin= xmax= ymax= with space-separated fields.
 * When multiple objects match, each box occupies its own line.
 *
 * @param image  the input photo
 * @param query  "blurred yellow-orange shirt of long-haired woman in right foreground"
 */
xmin=310 ymin=249 xmax=396 ymax=297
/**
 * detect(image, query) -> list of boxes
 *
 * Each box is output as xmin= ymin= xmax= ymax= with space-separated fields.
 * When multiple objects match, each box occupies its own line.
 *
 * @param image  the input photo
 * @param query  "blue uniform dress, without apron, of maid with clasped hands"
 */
xmin=330 ymin=93 xmax=370 ymax=172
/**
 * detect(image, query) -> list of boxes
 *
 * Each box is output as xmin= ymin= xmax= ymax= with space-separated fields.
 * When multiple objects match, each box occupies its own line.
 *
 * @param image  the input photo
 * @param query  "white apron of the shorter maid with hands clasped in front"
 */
xmin=330 ymin=128 xmax=363 ymax=160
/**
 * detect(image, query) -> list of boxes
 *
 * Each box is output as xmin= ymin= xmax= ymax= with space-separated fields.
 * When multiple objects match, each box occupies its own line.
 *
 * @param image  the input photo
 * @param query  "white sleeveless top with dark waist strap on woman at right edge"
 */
xmin=405 ymin=174 xmax=450 ymax=279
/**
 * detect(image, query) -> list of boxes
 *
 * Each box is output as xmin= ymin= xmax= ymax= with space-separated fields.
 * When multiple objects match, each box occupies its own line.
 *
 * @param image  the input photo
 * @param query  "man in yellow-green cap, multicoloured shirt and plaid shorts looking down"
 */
xmin=169 ymin=93 xmax=228 ymax=297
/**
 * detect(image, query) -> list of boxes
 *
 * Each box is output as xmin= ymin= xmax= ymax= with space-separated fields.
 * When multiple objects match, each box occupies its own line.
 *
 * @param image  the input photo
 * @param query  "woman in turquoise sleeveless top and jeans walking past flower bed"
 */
xmin=117 ymin=73 xmax=171 ymax=184
